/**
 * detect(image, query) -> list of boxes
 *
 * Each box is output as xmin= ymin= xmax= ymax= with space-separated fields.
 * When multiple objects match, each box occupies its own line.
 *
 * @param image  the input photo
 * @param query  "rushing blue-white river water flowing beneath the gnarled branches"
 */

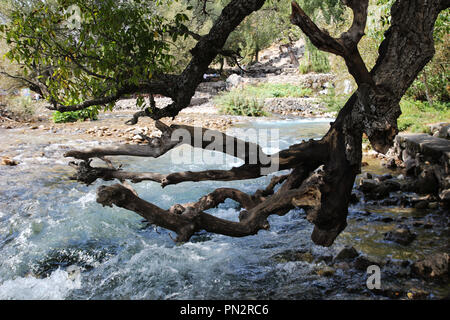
xmin=0 ymin=119 xmax=446 ymax=299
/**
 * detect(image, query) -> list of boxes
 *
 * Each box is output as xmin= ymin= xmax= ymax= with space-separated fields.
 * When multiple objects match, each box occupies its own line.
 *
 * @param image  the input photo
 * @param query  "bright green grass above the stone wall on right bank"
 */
xmin=398 ymin=99 xmax=450 ymax=133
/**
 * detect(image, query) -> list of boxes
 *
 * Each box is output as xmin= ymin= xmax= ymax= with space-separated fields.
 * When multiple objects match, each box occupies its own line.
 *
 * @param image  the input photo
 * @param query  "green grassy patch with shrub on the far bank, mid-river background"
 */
xmin=214 ymin=83 xmax=313 ymax=117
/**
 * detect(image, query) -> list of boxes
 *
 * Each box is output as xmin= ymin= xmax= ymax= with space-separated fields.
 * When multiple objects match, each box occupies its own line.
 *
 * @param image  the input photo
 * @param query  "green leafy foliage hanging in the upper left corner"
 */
xmin=0 ymin=0 xmax=188 ymax=107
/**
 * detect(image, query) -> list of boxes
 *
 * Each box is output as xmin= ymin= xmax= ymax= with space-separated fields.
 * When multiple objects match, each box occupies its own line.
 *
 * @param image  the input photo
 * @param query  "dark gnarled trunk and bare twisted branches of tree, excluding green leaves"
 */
xmin=67 ymin=0 xmax=449 ymax=246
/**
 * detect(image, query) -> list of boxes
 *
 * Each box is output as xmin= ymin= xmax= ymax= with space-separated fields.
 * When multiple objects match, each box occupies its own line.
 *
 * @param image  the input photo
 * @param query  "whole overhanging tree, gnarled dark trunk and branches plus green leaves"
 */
xmin=4 ymin=0 xmax=450 ymax=246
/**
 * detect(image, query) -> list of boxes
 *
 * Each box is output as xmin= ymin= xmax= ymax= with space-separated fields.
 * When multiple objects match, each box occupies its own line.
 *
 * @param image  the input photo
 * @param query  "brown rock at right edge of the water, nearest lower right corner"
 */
xmin=411 ymin=253 xmax=450 ymax=278
